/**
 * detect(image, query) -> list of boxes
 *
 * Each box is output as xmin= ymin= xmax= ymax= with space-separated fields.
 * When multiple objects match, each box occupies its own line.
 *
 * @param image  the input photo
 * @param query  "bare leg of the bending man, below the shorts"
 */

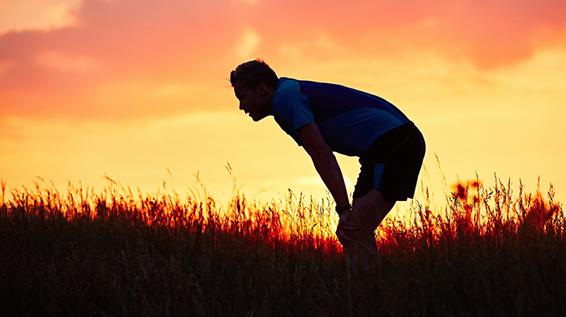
xmin=336 ymin=189 xmax=395 ymax=272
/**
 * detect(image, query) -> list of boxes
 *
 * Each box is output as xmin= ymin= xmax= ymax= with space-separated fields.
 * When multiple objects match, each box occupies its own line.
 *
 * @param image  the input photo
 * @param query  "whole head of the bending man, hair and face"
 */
xmin=230 ymin=60 xmax=279 ymax=121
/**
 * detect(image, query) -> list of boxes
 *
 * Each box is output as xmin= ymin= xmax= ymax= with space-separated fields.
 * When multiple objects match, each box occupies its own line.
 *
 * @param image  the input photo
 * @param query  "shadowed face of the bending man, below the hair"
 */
xmin=234 ymin=83 xmax=271 ymax=121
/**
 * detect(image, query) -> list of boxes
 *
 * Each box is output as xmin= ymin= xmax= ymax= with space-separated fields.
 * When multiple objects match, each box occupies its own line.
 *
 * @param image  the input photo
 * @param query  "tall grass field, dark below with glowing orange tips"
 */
xmin=0 ymin=179 xmax=566 ymax=316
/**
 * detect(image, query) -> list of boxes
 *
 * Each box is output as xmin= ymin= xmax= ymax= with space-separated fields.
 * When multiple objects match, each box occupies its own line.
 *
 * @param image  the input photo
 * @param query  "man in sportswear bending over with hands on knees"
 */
xmin=230 ymin=60 xmax=425 ymax=268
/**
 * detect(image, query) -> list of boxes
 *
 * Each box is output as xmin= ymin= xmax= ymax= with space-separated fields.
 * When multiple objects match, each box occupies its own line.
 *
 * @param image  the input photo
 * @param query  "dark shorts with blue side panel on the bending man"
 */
xmin=354 ymin=122 xmax=425 ymax=201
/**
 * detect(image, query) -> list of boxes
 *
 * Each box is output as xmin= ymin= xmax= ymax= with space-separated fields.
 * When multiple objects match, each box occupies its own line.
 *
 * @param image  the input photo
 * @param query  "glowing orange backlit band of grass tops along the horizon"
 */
xmin=1 ymin=176 xmax=566 ymax=253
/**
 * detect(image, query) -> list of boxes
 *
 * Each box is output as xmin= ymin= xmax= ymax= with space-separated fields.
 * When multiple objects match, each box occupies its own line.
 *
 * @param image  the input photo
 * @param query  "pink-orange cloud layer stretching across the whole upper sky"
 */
xmin=0 ymin=0 xmax=566 ymax=118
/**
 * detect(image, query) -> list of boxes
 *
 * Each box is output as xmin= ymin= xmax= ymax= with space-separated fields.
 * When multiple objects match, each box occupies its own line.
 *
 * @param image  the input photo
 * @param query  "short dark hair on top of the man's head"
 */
xmin=230 ymin=59 xmax=279 ymax=89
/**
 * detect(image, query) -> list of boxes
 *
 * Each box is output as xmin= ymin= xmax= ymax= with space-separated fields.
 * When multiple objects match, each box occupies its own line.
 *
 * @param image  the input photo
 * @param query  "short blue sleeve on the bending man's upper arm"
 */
xmin=273 ymin=90 xmax=314 ymax=145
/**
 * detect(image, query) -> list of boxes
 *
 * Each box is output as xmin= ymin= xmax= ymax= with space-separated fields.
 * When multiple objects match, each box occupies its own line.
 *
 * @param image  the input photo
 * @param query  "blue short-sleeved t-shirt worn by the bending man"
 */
xmin=273 ymin=77 xmax=410 ymax=156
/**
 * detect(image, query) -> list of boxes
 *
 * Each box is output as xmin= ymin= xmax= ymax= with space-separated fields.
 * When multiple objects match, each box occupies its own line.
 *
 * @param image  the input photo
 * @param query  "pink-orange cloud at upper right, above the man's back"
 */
xmin=250 ymin=0 xmax=566 ymax=69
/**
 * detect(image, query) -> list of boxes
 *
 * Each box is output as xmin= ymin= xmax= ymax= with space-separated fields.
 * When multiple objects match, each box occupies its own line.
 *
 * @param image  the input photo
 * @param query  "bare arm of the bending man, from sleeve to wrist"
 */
xmin=298 ymin=122 xmax=350 ymax=206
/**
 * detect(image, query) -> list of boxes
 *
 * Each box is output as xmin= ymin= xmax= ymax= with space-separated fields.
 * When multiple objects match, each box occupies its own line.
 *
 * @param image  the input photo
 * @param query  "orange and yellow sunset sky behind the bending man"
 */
xmin=0 ymin=0 xmax=566 ymax=209
